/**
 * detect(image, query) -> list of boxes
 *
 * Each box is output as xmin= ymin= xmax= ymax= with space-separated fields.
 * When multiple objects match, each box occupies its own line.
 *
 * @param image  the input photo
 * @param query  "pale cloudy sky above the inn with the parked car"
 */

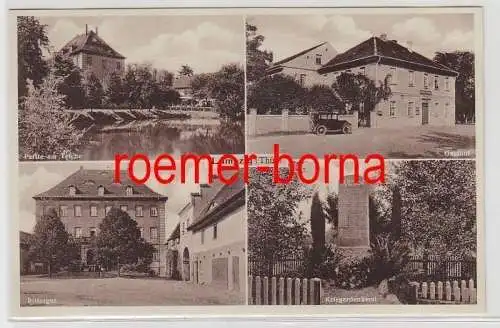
xmin=247 ymin=13 xmax=474 ymax=61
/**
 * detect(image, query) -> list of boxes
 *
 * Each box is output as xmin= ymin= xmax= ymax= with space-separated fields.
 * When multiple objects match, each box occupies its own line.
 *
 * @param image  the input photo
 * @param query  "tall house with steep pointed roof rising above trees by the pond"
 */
xmin=59 ymin=26 xmax=125 ymax=86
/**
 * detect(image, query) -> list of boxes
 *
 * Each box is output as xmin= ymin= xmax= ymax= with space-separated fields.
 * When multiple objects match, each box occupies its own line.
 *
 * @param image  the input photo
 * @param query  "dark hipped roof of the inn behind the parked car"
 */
xmin=318 ymin=37 xmax=458 ymax=76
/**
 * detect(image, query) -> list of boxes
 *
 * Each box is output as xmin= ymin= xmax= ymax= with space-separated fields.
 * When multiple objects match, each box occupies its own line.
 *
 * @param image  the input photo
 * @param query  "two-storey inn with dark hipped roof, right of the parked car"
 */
xmin=269 ymin=34 xmax=458 ymax=127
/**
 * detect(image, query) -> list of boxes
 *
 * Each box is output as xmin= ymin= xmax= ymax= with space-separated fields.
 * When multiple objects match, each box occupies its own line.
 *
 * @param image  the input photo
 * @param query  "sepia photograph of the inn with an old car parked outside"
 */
xmin=246 ymin=10 xmax=478 ymax=159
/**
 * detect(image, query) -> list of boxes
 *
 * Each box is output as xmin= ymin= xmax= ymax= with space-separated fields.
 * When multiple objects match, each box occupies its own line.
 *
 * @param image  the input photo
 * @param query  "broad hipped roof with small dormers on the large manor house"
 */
xmin=33 ymin=167 xmax=167 ymax=200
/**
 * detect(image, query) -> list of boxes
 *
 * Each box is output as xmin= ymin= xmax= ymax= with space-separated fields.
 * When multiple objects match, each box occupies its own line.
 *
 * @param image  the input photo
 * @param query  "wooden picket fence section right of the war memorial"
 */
xmin=412 ymin=279 xmax=477 ymax=304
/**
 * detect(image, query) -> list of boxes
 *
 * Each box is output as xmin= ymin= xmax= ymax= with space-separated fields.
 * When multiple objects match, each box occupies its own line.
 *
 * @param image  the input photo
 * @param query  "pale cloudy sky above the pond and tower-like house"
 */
xmin=39 ymin=15 xmax=245 ymax=73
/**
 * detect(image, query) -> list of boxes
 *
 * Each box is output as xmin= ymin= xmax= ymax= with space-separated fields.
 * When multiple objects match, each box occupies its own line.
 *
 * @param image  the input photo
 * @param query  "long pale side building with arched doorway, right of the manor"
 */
xmin=166 ymin=179 xmax=246 ymax=292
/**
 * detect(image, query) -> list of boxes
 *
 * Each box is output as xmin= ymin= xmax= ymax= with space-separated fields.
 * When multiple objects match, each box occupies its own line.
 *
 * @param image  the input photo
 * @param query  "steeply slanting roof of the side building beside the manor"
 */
xmin=188 ymin=179 xmax=245 ymax=231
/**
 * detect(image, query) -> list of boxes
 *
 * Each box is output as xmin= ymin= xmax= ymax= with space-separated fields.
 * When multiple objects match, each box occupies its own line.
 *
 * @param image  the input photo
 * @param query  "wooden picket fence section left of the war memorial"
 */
xmin=248 ymin=276 xmax=321 ymax=305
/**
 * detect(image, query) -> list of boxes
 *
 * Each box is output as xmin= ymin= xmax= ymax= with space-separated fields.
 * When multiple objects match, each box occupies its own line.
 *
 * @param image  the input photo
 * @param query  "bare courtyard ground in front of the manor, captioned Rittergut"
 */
xmin=20 ymin=277 xmax=245 ymax=306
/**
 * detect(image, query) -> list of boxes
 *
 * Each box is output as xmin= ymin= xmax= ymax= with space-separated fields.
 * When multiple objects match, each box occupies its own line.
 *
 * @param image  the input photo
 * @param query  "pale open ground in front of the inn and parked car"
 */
xmin=247 ymin=125 xmax=476 ymax=159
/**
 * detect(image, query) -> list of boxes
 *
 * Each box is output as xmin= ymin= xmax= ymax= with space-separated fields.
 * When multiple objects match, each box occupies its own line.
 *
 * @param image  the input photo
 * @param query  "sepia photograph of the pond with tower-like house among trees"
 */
xmin=17 ymin=15 xmax=245 ymax=161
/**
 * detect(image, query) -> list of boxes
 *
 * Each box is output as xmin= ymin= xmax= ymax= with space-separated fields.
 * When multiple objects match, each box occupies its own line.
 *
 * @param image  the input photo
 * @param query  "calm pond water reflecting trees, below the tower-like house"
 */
xmin=81 ymin=118 xmax=245 ymax=160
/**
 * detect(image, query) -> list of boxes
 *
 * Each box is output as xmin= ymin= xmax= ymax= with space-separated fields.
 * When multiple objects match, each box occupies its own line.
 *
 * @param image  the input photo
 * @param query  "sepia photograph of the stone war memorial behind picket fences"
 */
xmin=247 ymin=160 xmax=480 ymax=305
